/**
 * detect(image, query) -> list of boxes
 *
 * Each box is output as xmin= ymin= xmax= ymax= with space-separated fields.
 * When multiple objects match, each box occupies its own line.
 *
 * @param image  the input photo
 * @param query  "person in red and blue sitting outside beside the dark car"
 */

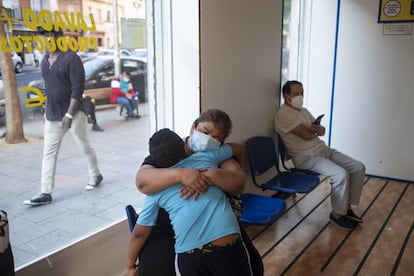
xmin=110 ymin=71 xmax=141 ymax=118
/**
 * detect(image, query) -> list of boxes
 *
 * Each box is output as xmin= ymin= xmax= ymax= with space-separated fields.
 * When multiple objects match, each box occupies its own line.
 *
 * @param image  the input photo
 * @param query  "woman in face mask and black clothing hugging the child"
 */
xmin=130 ymin=109 xmax=264 ymax=276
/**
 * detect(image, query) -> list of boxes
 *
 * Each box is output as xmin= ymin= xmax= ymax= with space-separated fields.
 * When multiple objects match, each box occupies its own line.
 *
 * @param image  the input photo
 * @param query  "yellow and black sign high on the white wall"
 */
xmin=378 ymin=0 xmax=414 ymax=23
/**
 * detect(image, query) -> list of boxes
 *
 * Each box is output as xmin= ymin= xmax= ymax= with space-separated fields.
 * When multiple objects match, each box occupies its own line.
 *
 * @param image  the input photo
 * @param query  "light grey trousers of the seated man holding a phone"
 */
xmin=296 ymin=148 xmax=365 ymax=215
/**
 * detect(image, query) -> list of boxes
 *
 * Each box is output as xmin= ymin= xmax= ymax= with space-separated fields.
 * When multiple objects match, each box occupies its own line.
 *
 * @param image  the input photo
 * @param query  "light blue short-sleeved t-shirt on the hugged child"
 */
xmin=137 ymin=144 xmax=240 ymax=253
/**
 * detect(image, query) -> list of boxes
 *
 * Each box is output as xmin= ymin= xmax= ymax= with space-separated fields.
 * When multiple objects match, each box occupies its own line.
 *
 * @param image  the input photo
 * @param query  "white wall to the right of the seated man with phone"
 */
xmin=307 ymin=0 xmax=414 ymax=181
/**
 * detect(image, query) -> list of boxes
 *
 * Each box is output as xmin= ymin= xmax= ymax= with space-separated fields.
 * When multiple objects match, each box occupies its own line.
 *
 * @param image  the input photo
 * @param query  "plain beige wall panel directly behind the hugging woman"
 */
xmin=200 ymin=0 xmax=282 ymax=192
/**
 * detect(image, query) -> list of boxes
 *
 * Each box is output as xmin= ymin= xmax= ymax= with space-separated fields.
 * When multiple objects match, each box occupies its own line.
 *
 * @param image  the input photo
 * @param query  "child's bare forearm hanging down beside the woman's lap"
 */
xmin=127 ymin=224 xmax=152 ymax=276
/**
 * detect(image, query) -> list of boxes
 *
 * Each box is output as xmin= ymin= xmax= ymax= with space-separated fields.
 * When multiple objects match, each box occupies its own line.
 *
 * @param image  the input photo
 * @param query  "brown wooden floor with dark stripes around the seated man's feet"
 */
xmin=252 ymin=178 xmax=414 ymax=276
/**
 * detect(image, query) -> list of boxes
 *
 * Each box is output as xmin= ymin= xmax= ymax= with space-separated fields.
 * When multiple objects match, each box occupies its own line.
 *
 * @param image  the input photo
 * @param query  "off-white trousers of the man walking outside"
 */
xmin=40 ymin=111 xmax=100 ymax=194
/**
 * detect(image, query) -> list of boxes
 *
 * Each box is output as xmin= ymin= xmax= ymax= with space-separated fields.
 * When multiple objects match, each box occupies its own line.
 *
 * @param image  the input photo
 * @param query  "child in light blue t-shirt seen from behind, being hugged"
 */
xmin=127 ymin=126 xmax=251 ymax=276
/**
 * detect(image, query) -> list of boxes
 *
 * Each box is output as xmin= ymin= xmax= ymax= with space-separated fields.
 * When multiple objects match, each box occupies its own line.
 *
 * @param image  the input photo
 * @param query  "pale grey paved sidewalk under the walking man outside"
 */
xmin=0 ymin=104 xmax=150 ymax=269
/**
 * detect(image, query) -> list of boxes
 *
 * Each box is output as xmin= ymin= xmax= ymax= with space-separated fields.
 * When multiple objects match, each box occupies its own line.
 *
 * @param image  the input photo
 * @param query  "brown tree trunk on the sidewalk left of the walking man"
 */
xmin=0 ymin=1 xmax=27 ymax=144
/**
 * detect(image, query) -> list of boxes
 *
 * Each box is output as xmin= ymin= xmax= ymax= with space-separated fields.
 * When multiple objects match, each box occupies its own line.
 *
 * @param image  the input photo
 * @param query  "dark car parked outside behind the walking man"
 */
xmin=27 ymin=56 xmax=147 ymax=106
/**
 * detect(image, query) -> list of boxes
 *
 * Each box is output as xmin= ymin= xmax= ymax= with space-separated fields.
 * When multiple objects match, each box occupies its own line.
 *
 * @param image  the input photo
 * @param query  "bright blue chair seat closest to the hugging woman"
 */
xmin=240 ymin=193 xmax=286 ymax=225
